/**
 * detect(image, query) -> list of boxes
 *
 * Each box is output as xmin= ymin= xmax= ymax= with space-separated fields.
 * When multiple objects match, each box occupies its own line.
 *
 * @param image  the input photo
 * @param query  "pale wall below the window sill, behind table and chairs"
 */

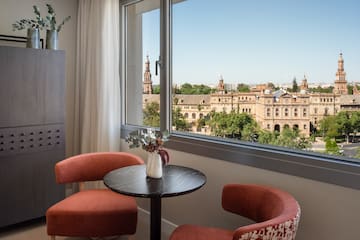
xmin=122 ymin=142 xmax=360 ymax=240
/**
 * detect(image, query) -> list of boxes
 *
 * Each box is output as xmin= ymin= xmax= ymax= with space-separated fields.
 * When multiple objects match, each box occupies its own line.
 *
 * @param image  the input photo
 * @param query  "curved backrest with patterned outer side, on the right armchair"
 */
xmin=222 ymin=184 xmax=300 ymax=240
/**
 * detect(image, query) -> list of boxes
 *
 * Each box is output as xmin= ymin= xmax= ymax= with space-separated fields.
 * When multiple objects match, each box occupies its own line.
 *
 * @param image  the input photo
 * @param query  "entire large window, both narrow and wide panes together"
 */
xmin=122 ymin=0 xmax=360 ymax=189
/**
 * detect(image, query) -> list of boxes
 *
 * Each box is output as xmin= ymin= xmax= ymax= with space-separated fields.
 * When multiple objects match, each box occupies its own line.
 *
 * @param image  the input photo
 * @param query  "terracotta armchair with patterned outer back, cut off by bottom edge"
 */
xmin=170 ymin=184 xmax=300 ymax=240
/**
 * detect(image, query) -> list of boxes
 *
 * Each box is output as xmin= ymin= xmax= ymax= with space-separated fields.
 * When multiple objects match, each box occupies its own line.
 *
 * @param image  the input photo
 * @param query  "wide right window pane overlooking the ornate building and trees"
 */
xmin=172 ymin=0 xmax=360 ymax=161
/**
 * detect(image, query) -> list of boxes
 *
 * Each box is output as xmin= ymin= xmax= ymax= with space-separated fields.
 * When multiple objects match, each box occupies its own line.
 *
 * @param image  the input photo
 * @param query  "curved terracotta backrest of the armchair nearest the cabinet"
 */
xmin=55 ymin=152 xmax=144 ymax=183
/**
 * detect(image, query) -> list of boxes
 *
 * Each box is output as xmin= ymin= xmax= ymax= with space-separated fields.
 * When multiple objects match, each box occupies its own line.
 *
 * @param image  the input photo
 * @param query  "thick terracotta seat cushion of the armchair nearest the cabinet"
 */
xmin=46 ymin=189 xmax=137 ymax=237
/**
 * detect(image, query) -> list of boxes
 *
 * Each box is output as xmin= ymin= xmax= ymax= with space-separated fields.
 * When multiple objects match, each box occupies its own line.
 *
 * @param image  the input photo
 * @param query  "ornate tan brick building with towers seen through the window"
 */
xmin=143 ymin=54 xmax=360 ymax=136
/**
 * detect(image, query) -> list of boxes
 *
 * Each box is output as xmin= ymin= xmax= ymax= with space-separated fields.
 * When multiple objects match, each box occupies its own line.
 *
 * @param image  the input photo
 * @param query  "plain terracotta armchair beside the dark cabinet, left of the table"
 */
xmin=46 ymin=152 xmax=144 ymax=240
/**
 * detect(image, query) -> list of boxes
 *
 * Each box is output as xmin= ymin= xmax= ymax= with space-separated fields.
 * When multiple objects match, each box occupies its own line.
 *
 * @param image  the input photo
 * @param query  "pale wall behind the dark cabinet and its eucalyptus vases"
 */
xmin=0 ymin=0 xmax=78 ymax=156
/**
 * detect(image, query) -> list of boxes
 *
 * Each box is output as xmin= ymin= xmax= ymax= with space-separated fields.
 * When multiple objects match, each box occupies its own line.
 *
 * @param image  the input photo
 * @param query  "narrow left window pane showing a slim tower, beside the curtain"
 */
xmin=125 ymin=0 xmax=160 ymax=127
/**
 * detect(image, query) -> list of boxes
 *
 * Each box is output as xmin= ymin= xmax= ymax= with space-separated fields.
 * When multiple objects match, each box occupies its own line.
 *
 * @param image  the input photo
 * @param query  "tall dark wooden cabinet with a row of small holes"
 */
xmin=0 ymin=46 xmax=65 ymax=227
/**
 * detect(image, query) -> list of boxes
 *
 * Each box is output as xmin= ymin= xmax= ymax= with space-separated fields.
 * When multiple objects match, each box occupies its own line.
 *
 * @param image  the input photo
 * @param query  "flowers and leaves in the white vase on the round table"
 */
xmin=125 ymin=128 xmax=169 ymax=164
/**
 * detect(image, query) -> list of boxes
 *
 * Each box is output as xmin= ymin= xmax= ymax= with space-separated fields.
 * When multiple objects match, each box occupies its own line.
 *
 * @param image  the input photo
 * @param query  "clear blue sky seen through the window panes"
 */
xmin=143 ymin=0 xmax=360 ymax=85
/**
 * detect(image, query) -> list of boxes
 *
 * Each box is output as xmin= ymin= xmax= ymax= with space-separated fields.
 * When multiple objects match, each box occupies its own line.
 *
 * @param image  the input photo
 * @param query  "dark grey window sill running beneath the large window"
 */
xmin=121 ymin=126 xmax=360 ymax=189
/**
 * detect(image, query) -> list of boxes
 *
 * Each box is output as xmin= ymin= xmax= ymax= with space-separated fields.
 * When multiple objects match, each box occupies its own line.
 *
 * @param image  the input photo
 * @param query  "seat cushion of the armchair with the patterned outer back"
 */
xmin=170 ymin=224 xmax=233 ymax=240
